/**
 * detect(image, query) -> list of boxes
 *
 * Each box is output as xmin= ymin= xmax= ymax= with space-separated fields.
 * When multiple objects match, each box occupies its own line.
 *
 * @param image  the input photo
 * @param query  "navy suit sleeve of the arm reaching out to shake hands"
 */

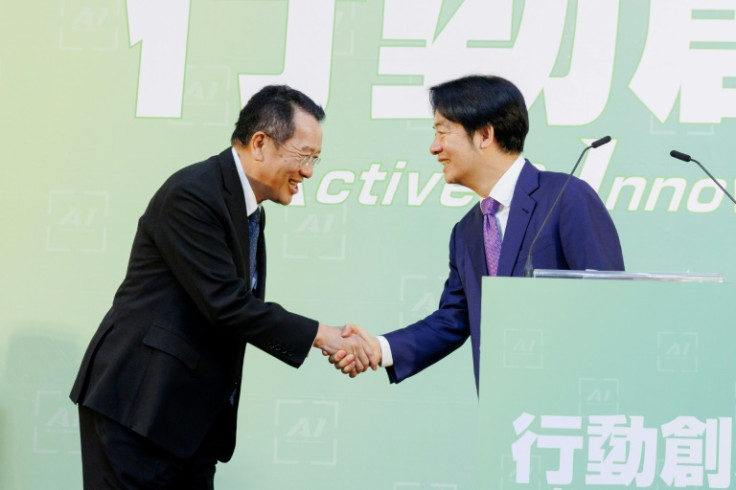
xmin=384 ymin=225 xmax=470 ymax=383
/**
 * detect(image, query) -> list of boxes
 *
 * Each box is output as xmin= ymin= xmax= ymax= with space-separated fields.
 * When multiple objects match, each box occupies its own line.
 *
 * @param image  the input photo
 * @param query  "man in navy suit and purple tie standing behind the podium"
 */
xmin=330 ymin=76 xmax=624 ymax=388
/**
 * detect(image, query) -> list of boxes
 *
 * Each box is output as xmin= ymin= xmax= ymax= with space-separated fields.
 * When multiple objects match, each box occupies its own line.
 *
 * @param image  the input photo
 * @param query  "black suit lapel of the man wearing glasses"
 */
xmin=218 ymin=148 xmax=250 ymax=285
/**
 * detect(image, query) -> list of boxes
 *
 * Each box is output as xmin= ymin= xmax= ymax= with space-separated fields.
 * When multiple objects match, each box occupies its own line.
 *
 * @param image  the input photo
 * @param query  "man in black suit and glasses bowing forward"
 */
xmin=71 ymin=86 xmax=376 ymax=490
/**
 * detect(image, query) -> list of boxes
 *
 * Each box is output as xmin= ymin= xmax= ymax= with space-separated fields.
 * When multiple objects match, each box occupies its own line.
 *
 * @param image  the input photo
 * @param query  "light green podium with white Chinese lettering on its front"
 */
xmin=477 ymin=271 xmax=736 ymax=490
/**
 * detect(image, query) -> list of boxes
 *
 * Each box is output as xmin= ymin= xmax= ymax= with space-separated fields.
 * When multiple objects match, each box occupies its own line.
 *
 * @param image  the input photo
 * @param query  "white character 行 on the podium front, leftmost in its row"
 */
xmin=511 ymin=413 xmax=583 ymax=485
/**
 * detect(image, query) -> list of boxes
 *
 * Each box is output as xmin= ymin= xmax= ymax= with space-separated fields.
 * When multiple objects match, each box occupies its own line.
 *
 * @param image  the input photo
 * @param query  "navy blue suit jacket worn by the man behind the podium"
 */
xmin=385 ymin=161 xmax=624 ymax=388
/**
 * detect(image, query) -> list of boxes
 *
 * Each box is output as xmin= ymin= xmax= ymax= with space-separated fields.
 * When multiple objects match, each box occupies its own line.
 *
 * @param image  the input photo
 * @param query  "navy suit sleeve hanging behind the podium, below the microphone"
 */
xmin=560 ymin=179 xmax=624 ymax=271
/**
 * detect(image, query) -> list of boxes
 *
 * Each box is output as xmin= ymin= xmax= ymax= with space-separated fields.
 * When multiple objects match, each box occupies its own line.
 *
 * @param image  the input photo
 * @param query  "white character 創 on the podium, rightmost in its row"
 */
xmin=660 ymin=416 xmax=732 ymax=488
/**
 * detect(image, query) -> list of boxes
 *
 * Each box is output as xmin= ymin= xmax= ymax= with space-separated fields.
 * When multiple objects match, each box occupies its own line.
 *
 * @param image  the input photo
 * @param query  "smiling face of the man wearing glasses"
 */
xmin=258 ymin=110 xmax=322 ymax=204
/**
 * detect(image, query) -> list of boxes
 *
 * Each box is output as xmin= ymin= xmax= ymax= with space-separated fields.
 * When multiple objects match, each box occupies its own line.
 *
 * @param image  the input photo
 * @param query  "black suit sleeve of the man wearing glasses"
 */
xmin=147 ymin=180 xmax=318 ymax=366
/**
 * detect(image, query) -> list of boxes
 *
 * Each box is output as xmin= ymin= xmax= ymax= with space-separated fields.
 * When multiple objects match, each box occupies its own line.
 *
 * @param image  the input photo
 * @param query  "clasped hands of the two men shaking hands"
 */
xmin=314 ymin=323 xmax=381 ymax=378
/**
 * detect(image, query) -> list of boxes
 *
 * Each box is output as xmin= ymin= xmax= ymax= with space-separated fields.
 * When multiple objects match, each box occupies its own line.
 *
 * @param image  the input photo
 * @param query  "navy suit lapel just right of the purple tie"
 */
xmin=498 ymin=160 xmax=539 ymax=276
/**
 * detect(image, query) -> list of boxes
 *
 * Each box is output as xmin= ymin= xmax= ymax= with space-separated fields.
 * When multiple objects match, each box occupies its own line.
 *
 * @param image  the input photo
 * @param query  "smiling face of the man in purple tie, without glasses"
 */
xmin=429 ymin=112 xmax=481 ymax=186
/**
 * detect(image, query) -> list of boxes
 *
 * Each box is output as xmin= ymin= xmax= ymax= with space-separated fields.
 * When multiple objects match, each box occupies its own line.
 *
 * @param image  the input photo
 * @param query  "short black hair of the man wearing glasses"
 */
xmin=231 ymin=85 xmax=325 ymax=145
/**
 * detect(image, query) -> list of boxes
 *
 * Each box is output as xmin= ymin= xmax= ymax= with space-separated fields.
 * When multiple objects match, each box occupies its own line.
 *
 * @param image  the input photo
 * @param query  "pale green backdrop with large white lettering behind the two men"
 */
xmin=0 ymin=0 xmax=736 ymax=490
